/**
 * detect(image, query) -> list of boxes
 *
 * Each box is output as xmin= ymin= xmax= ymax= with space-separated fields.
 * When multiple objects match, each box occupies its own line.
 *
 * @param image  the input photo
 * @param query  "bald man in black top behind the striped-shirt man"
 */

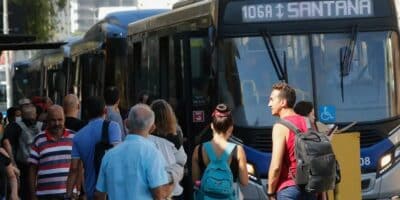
xmin=63 ymin=94 xmax=86 ymax=132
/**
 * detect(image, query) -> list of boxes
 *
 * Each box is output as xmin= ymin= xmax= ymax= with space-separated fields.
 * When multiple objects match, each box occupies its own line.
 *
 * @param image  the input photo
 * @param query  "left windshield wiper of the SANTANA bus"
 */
xmin=261 ymin=32 xmax=288 ymax=83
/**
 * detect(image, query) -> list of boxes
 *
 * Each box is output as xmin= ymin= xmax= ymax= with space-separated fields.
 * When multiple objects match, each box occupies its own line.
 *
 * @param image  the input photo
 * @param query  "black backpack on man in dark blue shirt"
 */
xmin=93 ymin=120 xmax=113 ymax=180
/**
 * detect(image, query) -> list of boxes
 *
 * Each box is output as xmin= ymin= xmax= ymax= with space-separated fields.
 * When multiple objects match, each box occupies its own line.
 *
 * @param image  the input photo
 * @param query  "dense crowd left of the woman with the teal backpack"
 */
xmin=0 ymin=87 xmax=194 ymax=200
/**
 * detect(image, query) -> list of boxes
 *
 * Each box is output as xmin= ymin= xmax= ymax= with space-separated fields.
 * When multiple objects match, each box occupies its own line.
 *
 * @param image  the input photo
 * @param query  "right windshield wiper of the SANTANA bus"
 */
xmin=340 ymin=25 xmax=358 ymax=102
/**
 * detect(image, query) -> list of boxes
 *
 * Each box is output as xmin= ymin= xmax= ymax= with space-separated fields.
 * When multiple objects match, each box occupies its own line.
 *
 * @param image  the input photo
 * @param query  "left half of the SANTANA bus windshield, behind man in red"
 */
xmin=220 ymin=35 xmax=313 ymax=127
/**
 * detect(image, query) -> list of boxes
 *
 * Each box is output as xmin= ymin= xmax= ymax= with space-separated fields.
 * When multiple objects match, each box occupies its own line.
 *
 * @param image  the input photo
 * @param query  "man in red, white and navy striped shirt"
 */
xmin=28 ymin=105 xmax=73 ymax=200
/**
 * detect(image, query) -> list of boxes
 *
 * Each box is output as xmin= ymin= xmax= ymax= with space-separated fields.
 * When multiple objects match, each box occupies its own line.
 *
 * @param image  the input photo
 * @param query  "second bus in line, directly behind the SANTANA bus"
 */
xmin=64 ymin=9 xmax=167 ymax=115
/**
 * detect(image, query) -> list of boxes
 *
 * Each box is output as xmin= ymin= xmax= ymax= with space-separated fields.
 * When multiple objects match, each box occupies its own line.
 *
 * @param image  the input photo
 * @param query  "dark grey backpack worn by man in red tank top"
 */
xmin=278 ymin=118 xmax=340 ymax=192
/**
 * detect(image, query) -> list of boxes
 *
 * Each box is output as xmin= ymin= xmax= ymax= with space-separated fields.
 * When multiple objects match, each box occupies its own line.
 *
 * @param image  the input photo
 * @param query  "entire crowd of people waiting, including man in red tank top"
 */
xmin=0 ymin=83 xmax=336 ymax=200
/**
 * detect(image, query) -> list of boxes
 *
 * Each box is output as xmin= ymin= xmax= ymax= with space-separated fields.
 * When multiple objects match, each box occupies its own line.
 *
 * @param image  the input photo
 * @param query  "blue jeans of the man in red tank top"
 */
xmin=276 ymin=186 xmax=317 ymax=200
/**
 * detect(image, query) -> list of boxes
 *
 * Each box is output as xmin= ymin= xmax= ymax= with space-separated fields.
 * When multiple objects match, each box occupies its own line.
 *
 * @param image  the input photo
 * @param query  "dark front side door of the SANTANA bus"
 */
xmin=175 ymin=33 xmax=213 ymax=153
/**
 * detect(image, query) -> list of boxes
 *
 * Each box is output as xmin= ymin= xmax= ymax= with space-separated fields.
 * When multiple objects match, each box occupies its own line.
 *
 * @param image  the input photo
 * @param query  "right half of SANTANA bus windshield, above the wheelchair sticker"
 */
xmin=313 ymin=32 xmax=395 ymax=122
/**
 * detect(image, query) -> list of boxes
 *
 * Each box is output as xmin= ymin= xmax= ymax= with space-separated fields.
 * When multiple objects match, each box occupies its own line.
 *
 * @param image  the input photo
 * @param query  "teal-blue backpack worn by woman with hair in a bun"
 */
xmin=196 ymin=142 xmax=236 ymax=200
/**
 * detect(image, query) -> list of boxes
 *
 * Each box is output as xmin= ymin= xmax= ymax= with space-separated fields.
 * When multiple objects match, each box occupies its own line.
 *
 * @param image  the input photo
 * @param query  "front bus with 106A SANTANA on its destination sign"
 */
xmin=126 ymin=0 xmax=400 ymax=199
